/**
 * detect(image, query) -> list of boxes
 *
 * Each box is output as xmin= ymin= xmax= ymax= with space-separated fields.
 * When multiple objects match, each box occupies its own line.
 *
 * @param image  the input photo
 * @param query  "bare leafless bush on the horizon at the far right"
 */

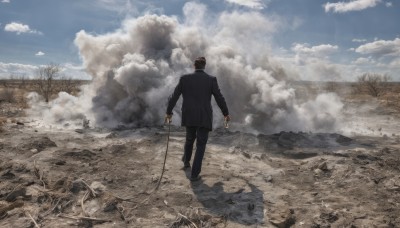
xmin=356 ymin=73 xmax=390 ymax=97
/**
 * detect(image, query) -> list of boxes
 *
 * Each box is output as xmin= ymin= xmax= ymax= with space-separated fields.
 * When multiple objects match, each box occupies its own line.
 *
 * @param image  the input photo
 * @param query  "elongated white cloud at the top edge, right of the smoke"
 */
xmin=323 ymin=0 xmax=382 ymax=13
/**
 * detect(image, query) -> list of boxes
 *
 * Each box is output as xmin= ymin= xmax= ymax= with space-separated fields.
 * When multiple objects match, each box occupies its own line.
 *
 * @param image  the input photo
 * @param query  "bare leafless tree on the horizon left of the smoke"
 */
xmin=37 ymin=63 xmax=61 ymax=102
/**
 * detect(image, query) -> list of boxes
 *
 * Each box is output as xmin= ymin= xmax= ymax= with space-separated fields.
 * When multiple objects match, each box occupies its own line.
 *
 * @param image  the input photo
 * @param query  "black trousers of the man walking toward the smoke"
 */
xmin=182 ymin=127 xmax=209 ymax=177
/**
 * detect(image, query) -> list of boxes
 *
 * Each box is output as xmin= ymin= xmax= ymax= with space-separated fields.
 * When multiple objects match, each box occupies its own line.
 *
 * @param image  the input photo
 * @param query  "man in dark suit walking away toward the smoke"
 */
xmin=165 ymin=57 xmax=230 ymax=181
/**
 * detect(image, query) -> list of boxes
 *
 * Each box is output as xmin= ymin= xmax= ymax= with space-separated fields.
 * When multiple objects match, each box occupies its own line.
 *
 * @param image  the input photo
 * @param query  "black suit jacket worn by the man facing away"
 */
xmin=167 ymin=70 xmax=229 ymax=130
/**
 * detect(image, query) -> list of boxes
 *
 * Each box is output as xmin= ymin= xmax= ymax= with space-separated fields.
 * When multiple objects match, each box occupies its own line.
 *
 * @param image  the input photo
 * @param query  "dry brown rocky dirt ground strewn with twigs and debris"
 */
xmin=0 ymin=83 xmax=400 ymax=228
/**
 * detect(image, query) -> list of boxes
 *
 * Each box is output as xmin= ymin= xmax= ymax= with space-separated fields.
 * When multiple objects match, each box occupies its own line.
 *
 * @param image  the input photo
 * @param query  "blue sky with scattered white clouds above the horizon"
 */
xmin=0 ymin=0 xmax=400 ymax=81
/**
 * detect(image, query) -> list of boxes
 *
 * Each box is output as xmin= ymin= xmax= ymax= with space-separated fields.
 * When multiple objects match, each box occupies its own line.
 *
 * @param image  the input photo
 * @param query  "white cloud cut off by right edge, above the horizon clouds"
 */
xmin=355 ymin=38 xmax=400 ymax=57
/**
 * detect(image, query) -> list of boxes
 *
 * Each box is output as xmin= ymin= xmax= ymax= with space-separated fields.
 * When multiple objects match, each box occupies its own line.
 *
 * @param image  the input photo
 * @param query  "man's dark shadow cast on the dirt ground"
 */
xmin=185 ymin=170 xmax=264 ymax=225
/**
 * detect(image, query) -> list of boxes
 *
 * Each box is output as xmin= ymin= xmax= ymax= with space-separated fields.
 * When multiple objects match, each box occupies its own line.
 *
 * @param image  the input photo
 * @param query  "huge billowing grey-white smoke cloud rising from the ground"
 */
xmin=27 ymin=2 xmax=343 ymax=132
